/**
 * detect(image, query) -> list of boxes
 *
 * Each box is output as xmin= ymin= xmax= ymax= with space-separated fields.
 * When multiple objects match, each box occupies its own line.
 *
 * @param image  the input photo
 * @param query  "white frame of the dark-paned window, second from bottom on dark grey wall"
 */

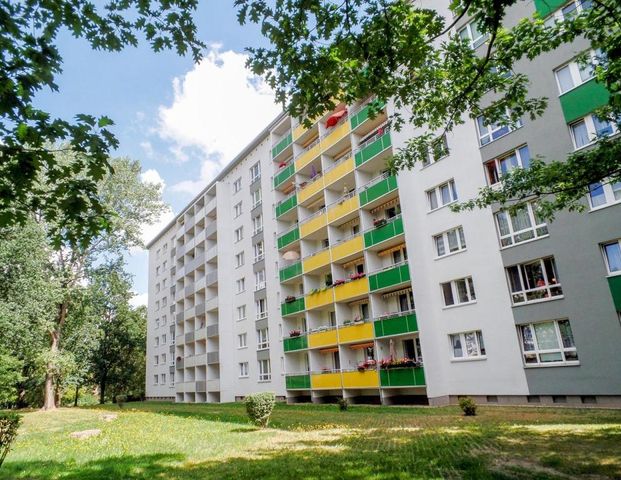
xmin=505 ymin=256 xmax=564 ymax=306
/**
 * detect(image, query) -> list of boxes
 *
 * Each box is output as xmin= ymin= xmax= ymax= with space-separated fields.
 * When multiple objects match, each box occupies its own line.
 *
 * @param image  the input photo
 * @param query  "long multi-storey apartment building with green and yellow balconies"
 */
xmin=147 ymin=0 xmax=621 ymax=405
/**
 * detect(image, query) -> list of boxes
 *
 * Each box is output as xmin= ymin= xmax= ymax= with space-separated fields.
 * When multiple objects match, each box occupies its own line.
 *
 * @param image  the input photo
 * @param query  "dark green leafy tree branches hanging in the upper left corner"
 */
xmin=0 ymin=0 xmax=204 ymax=243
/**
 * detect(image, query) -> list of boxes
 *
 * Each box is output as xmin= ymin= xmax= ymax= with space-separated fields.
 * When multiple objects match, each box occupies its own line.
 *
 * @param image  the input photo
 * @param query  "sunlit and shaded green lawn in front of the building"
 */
xmin=0 ymin=403 xmax=621 ymax=480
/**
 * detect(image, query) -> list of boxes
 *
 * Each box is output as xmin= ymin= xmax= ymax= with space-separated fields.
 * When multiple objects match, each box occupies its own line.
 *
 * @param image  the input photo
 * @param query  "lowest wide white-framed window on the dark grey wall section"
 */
xmin=518 ymin=320 xmax=578 ymax=365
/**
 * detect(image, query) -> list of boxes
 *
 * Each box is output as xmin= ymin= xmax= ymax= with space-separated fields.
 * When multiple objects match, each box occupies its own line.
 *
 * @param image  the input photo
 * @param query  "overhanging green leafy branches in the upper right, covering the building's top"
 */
xmin=235 ymin=0 xmax=621 ymax=218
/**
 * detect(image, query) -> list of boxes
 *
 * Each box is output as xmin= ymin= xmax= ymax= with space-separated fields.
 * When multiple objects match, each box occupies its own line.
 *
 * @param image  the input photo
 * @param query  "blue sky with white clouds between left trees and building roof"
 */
xmin=37 ymin=0 xmax=280 ymax=304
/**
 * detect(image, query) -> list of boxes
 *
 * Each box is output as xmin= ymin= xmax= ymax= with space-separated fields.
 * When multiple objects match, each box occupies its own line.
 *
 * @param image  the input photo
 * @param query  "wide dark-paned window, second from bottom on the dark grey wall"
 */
xmin=507 ymin=257 xmax=563 ymax=305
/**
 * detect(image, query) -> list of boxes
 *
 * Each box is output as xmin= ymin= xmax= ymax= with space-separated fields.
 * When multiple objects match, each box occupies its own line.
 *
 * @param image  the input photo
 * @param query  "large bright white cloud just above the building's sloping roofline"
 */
xmin=157 ymin=46 xmax=280 ymax=195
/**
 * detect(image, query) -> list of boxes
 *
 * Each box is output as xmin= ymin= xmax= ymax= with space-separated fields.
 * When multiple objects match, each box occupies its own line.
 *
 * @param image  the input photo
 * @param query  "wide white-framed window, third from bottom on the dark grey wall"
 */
xmin=494 ymin=203 xmax=548 ymax=247
